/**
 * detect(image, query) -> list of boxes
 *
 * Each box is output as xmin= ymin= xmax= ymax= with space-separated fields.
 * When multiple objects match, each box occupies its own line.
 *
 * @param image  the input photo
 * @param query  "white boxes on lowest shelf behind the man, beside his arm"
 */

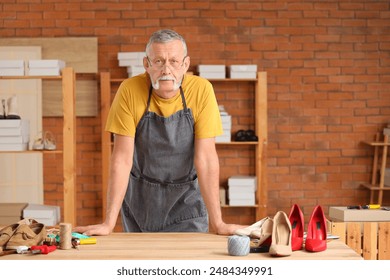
xmin=228 ymin=175 xmax=257 ymax=206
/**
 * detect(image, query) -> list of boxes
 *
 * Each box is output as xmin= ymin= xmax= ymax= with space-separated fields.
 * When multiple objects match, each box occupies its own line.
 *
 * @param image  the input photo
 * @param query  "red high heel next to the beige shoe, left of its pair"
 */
xmin=288 ymin=204 xmax=304 ymax=251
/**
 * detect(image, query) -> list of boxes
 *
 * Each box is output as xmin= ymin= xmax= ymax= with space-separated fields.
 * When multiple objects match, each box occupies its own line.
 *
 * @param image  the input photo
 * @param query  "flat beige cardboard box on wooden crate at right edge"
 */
xmin=329 ymin=206 xmax=390 ymax=222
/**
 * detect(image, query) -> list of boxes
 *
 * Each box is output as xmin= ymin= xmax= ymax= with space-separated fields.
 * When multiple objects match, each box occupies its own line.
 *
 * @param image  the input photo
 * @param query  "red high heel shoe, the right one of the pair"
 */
xmin=305 ymin=205 xmax=326 ymax=252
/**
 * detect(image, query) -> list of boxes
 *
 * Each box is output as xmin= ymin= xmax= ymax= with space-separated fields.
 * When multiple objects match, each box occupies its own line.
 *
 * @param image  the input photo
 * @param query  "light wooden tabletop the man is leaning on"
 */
xmin=0 ymin=233 xmax=363 ymax=261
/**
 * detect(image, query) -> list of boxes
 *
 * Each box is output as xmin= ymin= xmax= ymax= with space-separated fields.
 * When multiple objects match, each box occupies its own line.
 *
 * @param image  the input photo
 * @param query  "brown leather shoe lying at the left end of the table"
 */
xmin=6 ymin=223 xmax=46 ymax=250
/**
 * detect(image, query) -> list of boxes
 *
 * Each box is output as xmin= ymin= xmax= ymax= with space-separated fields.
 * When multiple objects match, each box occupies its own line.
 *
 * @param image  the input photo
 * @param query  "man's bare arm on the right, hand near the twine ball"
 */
xmin=195 ymin=138 xmax=243 ymax=235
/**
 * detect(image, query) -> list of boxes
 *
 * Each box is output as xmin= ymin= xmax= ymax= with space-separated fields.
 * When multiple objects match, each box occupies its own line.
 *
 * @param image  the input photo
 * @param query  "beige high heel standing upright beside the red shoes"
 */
xmin=269 ymin=211 xmax=292 ymax=257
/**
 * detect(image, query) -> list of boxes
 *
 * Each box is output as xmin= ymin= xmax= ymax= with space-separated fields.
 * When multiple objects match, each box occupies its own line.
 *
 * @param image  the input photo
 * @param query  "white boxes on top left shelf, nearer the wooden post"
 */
xmin=27 ymin=59 xmax=65 ymax=76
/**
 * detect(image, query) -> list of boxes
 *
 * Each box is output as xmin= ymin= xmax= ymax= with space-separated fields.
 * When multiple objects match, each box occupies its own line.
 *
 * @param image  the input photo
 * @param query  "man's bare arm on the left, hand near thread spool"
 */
xmin=74 ymin=135 xmax=134 ymax=235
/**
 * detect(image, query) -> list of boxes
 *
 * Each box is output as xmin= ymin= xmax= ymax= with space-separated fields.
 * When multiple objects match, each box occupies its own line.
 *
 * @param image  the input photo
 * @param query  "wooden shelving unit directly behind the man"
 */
xmin=100 ymin=72 xmax=268 ymax=220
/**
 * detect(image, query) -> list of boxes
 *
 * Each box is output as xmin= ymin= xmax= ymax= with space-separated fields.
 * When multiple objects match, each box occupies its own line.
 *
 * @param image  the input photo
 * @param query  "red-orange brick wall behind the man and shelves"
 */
xmin=0 ymin=0 xmax=390 ymax=228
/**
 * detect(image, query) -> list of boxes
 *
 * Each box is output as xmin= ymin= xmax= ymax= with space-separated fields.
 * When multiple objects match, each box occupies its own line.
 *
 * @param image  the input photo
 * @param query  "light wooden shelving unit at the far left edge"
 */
xmin=0 ymin=67 xmax=76 ymax=226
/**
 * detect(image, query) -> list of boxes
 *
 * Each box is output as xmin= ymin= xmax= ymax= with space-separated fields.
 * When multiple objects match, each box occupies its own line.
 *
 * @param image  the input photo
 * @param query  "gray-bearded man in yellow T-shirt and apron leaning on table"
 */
xmin=74 ymin=30 xmax=241 ymax=235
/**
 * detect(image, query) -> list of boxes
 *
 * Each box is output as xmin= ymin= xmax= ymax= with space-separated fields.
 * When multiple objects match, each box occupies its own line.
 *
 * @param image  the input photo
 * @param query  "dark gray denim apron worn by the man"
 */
xmin=121 ymin=87 xmax=208 ymax=232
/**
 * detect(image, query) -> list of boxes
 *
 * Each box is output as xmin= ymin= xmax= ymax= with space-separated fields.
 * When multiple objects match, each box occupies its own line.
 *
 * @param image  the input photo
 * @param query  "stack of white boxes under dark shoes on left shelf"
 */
xmin=0 ymin=119 xmax=30 ymax=151
